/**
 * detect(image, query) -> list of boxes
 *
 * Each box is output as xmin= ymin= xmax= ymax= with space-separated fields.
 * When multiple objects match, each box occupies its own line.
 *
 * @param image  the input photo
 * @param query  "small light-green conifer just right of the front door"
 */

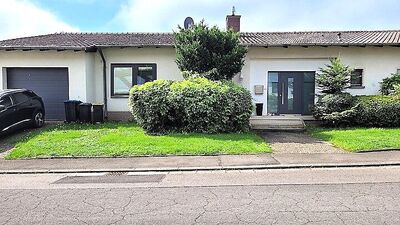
xmin=315 ymin=58 xmax=353 ymax=94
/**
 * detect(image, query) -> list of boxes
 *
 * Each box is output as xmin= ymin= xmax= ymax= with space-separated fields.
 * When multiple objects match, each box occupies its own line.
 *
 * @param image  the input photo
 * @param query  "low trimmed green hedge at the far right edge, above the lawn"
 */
xmin=355 ymin=96 xmax=400 ymax=127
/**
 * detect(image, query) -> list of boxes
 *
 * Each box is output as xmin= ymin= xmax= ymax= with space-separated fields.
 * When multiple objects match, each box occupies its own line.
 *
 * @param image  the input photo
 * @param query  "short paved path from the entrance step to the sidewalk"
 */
xmin=262 ymin=132 xmax=346 ymax=154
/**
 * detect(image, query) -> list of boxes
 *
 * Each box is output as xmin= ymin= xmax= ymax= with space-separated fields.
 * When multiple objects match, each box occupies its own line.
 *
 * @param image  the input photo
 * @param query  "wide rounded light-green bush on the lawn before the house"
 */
xmin=129 ymin=78 xmax=252 ymax=133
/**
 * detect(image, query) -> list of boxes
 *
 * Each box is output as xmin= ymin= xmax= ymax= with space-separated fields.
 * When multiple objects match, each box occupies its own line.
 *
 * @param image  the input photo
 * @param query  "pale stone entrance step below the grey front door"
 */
xmin=250 ymin=116 xmax=305 ymax=131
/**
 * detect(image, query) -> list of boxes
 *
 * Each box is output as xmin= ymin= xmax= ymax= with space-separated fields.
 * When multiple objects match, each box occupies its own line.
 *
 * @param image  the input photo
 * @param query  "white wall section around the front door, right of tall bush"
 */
xmin=241 ymin=47 xmax=400 ymax=114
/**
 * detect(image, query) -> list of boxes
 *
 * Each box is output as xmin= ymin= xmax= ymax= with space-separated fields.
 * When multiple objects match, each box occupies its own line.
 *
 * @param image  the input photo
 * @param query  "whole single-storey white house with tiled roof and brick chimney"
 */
xmin=0 ymin=15 xmax=400 ymax=120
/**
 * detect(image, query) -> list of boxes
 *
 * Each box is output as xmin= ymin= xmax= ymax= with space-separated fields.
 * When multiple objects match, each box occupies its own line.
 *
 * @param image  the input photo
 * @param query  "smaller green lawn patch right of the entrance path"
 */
xmin=308 ymin=127 xmax=400 ymax=152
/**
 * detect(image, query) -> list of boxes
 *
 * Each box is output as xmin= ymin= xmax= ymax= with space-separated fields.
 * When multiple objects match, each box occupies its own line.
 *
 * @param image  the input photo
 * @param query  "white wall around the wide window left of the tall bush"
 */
xmin=94 ymin=48 xmax=183 ymax=112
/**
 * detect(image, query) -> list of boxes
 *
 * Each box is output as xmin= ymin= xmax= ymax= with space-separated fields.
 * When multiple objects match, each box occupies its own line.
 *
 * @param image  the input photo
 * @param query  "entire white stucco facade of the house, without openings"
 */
xmin=0 ymin=47 xmax=400 ymax=119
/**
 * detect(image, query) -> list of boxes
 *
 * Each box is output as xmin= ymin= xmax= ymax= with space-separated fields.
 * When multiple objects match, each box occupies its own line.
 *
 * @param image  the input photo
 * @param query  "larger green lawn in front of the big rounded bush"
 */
xmin=6 ymin=123 xmax=271 ymax=159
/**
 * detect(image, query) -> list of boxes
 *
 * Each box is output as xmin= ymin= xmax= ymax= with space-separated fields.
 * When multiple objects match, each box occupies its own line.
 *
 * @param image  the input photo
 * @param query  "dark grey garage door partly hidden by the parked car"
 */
xmin=7 ymin=68 xmax=69 ymax=120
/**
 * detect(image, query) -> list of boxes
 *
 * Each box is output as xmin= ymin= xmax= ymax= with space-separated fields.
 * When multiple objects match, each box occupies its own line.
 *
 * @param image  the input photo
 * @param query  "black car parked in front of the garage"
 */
xmin=0 ymin=89 xmax=45 ymax=133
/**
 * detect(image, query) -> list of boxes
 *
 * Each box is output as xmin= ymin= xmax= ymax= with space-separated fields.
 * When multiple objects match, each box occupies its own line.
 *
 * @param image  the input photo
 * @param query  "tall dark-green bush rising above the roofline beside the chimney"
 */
xmin=175 ymin=21 xmax=247 ymax=80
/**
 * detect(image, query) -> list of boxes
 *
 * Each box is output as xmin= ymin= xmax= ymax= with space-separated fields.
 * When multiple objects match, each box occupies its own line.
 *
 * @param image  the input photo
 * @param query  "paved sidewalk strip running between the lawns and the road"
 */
xmin=0 ymin=151 xmax=400 ymax=174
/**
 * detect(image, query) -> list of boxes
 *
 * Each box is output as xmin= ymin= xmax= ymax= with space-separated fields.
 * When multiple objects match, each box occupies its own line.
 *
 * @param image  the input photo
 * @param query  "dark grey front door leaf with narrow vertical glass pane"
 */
xmin=278 ymin=72 xmax=304 ymax=114
